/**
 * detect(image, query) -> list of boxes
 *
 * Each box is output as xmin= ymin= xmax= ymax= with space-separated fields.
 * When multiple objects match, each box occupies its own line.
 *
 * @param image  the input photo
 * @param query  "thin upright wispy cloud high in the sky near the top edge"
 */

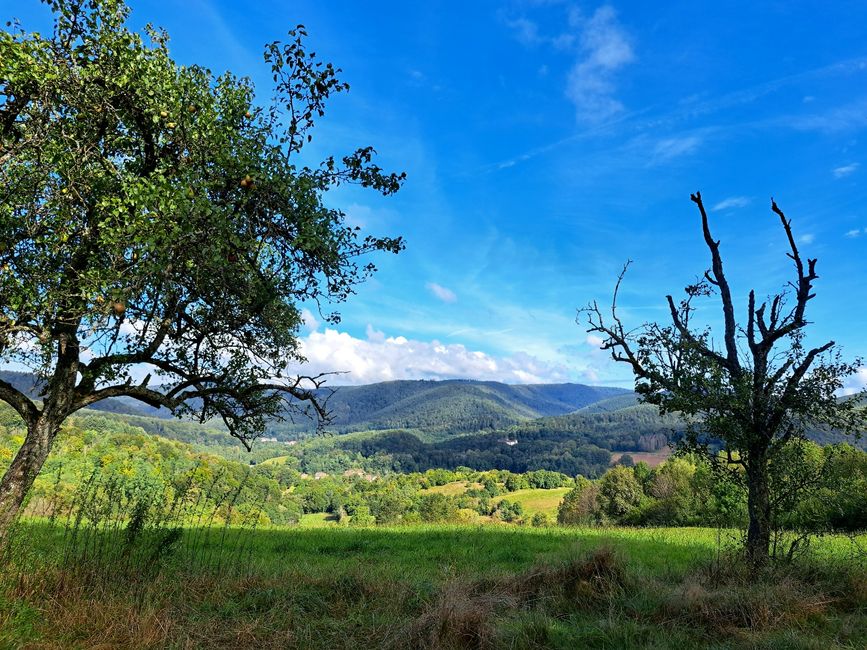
xmin=559 ymin=5 xmax=635 ymax=122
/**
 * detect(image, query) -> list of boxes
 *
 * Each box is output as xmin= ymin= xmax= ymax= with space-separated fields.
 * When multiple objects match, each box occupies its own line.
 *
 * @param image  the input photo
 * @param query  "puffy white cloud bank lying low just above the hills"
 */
xmin=293 ymin=325 xmax=570 ymax=384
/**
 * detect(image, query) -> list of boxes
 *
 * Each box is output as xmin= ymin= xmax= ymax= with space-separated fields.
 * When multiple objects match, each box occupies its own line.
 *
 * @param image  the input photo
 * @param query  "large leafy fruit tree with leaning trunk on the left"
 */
xmin=0 ymin=0 xmax=404 ymax=530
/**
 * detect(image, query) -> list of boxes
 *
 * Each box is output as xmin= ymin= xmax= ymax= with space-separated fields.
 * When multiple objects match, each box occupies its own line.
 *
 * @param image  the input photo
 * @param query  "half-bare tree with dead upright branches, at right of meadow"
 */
xmin=582 ymin=193 xmax=863 ymax=564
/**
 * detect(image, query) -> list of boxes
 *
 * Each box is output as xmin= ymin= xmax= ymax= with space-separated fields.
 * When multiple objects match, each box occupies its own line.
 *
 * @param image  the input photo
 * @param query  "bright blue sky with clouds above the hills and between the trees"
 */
xmin=6 ymin=0 xmax=867 ymax=385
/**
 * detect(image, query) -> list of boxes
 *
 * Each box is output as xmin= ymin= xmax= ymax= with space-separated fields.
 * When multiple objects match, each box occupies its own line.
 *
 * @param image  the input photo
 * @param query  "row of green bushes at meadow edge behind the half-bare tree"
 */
xmin=557 ymin=441 xmax=867 ymax=540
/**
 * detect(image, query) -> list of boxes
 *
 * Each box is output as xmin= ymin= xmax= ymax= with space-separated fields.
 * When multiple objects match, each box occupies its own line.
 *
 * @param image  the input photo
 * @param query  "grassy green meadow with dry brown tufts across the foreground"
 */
xmin=0 ymin=523 xmax=867 ymax=649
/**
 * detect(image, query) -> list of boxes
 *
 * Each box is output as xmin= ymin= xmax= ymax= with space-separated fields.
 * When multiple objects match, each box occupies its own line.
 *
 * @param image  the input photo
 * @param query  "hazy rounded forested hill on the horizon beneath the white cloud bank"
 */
xmin=300 ymin=380 xmax=631 ymax=433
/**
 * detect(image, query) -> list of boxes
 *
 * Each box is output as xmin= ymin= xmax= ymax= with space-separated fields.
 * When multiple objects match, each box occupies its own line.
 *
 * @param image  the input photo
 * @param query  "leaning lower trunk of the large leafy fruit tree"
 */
xmin=0 ymin=417 xmax=60 ymax=539
